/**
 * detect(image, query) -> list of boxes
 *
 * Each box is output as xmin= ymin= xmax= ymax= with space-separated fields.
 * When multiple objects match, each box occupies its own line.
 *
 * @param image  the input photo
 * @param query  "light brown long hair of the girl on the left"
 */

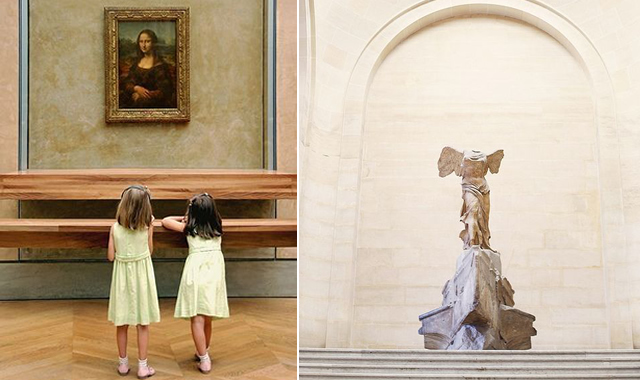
xmin=116 ymin=185 xmax=153 ymax=230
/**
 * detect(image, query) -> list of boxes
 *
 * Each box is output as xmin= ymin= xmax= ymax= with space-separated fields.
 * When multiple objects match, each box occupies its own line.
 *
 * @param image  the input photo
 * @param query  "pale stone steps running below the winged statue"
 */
xmin=299 ymin=348 xmax=640 ymax=380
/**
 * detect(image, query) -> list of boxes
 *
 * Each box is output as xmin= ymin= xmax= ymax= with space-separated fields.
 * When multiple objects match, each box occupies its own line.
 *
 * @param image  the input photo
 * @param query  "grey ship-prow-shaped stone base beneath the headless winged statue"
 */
xmin=418 ymin=246 xmax=536 ymax=350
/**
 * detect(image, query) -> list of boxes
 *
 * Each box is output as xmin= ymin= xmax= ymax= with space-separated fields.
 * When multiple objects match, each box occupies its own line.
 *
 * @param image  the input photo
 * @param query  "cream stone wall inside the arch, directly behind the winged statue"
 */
xmin=351 ymin=16 xmax=608 ymax=348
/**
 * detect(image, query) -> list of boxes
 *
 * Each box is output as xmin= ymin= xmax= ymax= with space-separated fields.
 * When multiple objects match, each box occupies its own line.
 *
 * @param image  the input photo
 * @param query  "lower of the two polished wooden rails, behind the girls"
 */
xmin=0 ymin=219 xmax=297 ymax=248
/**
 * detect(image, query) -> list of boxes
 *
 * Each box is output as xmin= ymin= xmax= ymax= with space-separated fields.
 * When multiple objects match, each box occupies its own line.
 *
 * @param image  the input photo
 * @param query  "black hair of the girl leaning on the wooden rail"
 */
xmin=184 ymin=193 xmax=222 ymax=239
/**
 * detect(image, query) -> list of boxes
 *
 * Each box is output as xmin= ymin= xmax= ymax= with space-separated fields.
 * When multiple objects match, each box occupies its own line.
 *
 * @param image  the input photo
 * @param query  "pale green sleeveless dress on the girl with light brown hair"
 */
xmin=109 ymin=222 xmax=160 ymax=326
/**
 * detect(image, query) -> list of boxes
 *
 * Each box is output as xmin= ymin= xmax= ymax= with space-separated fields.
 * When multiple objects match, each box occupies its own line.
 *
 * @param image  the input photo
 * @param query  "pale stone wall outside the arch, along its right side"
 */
xmin=549 ymin=0 xmax=640 ymax=348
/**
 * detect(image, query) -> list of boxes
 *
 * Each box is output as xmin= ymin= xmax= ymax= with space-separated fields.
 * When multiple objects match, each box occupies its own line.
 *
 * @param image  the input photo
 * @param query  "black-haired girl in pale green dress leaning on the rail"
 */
xmin=162 ymin=193 xmax=229 ymax=373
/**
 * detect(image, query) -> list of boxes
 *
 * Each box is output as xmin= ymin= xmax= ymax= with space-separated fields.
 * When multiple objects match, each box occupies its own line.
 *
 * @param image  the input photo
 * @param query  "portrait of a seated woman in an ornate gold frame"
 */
xmin=104 ymin=8 xmax=190 ymax=123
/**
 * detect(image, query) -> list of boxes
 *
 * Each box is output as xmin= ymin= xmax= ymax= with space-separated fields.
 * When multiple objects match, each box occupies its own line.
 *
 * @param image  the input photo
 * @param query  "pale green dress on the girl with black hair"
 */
xmin=174 ymin=236 xmax=229 ymax=318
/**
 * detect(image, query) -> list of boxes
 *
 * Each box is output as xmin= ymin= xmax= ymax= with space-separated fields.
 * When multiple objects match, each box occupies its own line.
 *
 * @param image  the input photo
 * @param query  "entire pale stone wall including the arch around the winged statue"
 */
xmin=300 ymin=0 xmax=640 ymax=349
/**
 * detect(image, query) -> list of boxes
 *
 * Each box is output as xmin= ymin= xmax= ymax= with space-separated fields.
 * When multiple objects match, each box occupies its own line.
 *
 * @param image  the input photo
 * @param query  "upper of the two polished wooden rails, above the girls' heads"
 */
xmin=0 ymin=169 xmax=297 ymax=200
